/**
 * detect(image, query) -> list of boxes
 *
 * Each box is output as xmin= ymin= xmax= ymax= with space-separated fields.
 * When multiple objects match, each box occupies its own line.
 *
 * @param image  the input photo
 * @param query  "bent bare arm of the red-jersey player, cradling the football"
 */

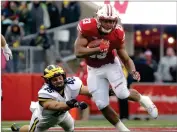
xmin=74 ymin=32 xmax=100 ymax=58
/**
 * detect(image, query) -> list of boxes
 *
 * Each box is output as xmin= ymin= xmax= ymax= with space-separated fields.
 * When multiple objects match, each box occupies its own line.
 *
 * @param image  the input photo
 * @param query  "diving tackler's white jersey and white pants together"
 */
xmin=29 ymin=77 xmax=82 ymax=132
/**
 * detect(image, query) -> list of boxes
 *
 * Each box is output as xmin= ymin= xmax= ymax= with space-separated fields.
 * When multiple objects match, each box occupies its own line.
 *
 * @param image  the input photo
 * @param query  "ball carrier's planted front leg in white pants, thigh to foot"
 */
xmin=87 ymin=65 xmax=129 ymax=131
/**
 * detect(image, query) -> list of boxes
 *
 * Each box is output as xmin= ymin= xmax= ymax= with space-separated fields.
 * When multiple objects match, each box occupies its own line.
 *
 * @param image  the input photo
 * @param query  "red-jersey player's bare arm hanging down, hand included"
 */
xmin=117 ymin=44 xmax=141 ymax=81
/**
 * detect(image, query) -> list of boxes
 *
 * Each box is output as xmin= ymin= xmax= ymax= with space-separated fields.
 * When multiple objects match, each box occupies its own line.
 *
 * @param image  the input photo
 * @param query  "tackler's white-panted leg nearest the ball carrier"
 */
xmin=58 ymin=112 xmax=74 ymax=132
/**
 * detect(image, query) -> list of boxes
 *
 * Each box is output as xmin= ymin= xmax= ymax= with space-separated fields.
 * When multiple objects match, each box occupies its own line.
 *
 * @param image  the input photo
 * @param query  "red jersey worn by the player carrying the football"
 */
xmin=77 ymin=18 xmax=125 ymax=67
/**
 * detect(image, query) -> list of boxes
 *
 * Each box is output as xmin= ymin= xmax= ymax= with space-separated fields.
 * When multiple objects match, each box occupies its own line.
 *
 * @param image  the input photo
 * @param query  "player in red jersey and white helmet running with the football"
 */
xmin=75 ymin=4 xmax=158 ymax=131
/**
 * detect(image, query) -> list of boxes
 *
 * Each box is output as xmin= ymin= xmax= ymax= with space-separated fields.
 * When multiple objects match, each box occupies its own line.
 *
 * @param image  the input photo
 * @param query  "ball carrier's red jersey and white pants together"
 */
xmin=78 ymin=18 xmax=130 ymax=109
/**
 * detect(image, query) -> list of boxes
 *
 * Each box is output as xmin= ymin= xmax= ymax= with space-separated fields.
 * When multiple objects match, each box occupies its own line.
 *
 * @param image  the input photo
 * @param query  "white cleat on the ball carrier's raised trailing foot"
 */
xmin=140 ymin=96 xmax=158 ymax=119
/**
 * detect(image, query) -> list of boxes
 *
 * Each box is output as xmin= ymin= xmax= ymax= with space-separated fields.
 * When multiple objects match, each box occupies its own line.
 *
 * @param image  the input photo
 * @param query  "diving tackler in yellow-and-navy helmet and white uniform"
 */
xmin=11 ymin=65 xmax=90 ymax=132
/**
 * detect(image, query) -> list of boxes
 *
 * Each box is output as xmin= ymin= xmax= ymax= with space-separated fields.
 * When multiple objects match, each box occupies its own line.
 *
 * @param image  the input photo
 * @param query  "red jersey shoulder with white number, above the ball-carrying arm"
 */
xmin=77 ymin=18 xmax=96 ymax=35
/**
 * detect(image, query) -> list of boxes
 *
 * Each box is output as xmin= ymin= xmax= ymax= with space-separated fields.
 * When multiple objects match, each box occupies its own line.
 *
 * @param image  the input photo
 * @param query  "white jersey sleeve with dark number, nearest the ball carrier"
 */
xmin=67 ymin=77 xmax=82 ymax=98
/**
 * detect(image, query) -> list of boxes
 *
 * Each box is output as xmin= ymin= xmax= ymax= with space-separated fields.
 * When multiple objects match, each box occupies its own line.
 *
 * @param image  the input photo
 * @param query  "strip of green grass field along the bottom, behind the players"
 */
xmin=1 ymin=120 xmax=177 ymax=131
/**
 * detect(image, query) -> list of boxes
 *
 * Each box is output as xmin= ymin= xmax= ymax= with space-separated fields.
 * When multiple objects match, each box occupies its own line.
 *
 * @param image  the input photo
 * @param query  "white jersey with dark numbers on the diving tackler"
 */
xmin=31 ymin=77 xmax=82 ymax=116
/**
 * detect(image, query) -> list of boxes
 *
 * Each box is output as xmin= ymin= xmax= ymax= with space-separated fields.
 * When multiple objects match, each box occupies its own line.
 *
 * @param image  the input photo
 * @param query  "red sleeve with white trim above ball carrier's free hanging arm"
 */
xmin=116 ymin=25 xmax=125 ymax=44
